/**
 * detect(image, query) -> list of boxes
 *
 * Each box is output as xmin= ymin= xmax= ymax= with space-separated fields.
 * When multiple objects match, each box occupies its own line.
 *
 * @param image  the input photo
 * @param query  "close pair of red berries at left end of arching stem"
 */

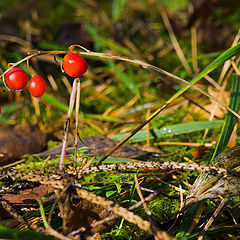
xmin=5 ymin=67 xmax=46 ymax=97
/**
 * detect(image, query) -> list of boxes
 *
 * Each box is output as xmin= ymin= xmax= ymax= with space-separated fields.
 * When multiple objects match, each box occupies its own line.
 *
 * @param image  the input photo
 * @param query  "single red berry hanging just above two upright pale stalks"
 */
xmin=63 ymin=53 xmax=88 ymax=77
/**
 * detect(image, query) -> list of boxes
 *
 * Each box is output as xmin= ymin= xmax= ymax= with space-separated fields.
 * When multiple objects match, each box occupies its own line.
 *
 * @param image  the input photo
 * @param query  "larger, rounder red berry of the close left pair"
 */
xmin=5 ymin=67 xmax=28 ymax=91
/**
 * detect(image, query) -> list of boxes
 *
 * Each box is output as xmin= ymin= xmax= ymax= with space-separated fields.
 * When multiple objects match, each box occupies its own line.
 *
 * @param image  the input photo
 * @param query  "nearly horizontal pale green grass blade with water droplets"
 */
xmin=114 ymin=120 xmax=224 ymax=142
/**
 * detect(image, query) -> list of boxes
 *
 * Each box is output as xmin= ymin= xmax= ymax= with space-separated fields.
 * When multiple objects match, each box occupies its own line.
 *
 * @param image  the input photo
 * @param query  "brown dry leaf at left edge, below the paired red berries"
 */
xmin=0 ymin=122 xmax=47 ymax=166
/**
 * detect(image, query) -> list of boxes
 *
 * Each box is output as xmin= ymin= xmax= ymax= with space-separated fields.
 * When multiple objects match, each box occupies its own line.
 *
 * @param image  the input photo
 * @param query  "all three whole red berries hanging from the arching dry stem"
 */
xmin=2 ymin=50 xmax=88 ymax=101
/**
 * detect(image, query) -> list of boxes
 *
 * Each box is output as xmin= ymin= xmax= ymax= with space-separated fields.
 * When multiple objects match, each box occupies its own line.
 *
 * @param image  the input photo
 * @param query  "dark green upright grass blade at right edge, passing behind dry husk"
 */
xmin=176 ymin=76 xmax=240 ymax=240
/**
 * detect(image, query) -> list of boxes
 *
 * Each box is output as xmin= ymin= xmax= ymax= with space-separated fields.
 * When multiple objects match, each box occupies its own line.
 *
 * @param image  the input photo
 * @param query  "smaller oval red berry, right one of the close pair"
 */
xmin=28 ymin=76 xmax=46 ymax=97
